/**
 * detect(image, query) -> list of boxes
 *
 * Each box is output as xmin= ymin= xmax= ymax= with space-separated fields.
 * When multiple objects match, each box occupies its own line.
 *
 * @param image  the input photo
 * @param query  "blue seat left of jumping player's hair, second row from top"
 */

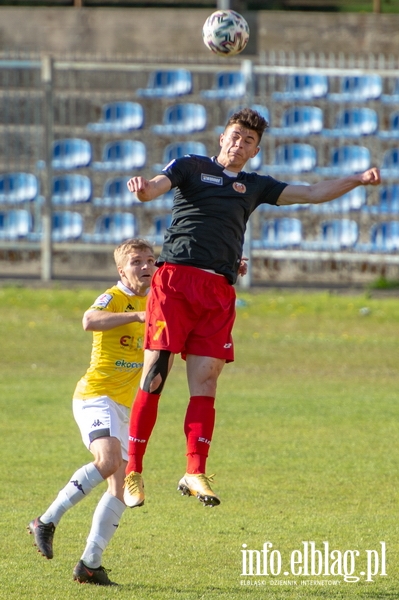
xmin=151 ymin=103 xmax=207 ymax=135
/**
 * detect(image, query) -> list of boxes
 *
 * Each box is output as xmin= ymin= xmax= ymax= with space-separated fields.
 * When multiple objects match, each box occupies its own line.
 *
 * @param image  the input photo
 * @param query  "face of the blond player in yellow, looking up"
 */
xmin=118 ymin=249 xmax=156 ymax=296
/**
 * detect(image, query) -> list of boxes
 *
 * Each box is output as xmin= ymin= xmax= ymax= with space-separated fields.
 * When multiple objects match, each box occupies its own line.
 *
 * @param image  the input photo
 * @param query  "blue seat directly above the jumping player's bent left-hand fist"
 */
xmin=92 ymin=140 xmax=146 ymax=171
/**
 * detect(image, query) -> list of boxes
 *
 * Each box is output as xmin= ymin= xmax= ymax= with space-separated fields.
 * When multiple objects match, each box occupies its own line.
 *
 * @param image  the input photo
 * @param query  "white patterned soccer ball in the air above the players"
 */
xmin=202 ymin=10 xmax=249 ymax=56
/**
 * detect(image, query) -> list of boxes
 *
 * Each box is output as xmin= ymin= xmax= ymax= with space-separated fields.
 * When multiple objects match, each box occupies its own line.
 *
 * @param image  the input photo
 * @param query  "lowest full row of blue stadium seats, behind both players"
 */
xmin=0 ymin=209 xmax=399 ymax=252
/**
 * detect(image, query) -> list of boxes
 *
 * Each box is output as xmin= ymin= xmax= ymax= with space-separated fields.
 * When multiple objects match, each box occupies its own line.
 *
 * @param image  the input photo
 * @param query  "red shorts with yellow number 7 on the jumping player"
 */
xmin=144 ymin=263 xmax=236 ymax=362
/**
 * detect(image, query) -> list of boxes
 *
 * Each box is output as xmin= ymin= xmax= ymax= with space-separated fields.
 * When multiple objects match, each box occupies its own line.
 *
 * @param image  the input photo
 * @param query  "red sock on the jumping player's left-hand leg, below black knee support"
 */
xmin=126 ymin=388 xmax=160 ymax=475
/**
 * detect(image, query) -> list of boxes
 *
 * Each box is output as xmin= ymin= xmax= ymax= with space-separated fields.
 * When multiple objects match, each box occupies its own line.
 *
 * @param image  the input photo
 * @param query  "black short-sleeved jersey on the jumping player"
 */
xmin=157 ymin=154 xmax=287 ymax=284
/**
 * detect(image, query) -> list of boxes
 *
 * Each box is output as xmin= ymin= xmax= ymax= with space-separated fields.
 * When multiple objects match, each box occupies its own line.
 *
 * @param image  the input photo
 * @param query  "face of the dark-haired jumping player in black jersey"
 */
xmin=218 ymin=123 xmax=259 ymax=172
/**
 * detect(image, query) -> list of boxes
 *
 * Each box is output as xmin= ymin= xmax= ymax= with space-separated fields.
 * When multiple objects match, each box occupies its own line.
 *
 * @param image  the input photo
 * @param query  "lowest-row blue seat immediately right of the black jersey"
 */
xmin=252 ymin=217 xmax=302 ymax=248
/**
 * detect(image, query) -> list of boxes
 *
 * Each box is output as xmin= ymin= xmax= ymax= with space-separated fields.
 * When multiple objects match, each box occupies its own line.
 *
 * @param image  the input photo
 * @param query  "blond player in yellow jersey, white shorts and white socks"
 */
xmin=28 ymin=239 xmax=155 ymax=585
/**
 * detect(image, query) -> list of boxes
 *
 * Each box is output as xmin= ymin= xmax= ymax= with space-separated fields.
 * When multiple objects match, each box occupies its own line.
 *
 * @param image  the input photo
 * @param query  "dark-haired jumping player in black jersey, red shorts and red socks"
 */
xmin=124 ymin=108 xmax=380 ymax=507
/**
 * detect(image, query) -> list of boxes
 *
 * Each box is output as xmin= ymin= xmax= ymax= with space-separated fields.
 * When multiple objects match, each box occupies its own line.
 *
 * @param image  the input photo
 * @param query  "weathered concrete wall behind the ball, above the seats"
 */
xmin=0 ymin=7 xmax=399 ymax=60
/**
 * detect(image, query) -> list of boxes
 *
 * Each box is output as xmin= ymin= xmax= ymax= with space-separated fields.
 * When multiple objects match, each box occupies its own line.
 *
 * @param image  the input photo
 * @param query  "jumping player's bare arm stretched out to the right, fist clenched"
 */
xmin=277 ymin=167 xmax=381 ymax=206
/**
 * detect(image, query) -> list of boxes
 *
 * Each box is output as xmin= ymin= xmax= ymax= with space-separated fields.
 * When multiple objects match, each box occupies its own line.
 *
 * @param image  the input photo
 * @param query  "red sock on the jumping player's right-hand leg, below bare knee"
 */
xmin=184 ymin=396 xmax=215 ymax=473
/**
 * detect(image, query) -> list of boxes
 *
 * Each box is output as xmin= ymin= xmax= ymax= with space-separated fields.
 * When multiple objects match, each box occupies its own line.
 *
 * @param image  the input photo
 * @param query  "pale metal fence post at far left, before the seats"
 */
xmin=41 ymin=56 xmax=54 ymax=281
